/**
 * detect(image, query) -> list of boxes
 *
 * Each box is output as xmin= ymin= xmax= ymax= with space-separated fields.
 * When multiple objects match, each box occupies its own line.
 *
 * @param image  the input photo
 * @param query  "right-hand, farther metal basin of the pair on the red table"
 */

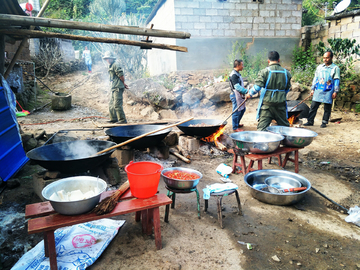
xmin=267 ymin=126 xmax=317 ymax=147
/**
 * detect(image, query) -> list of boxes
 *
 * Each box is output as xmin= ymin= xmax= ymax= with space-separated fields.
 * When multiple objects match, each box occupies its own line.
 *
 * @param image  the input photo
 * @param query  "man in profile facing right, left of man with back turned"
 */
xmin=229 ymin=59 xmax=248 ymax=132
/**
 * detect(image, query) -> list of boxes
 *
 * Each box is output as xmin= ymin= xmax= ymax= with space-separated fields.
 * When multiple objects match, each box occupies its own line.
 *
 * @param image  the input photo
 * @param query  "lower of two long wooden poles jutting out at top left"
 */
xmin=0 ymin=29 xmax=187 ymax=52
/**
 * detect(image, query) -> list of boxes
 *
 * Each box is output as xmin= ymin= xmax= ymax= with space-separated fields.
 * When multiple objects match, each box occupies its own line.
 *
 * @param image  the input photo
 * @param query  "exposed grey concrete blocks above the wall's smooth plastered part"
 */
xmin=174 ymin=0 xmax=302 ymax=37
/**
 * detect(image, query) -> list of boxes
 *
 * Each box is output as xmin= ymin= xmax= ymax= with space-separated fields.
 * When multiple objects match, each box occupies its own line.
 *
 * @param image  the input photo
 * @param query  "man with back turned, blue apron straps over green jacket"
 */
xmin=246 ymin=51 xmax=291 ymax=131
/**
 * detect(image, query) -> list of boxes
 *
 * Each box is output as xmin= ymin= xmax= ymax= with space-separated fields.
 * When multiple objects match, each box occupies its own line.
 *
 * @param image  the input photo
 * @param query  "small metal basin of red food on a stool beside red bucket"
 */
xmin=161 ymin=167 xmax=202 ymax=189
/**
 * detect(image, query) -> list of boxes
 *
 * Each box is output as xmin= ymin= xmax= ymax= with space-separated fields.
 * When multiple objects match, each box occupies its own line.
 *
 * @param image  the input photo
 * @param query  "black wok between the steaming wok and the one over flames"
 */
xmin=105 ymin=125 xmax=172 ymax=149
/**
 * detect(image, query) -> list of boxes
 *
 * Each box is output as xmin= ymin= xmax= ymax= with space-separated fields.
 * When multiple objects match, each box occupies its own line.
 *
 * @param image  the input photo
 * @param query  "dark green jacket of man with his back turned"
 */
xmin=255 ymin=64 xmax=291 ymax=104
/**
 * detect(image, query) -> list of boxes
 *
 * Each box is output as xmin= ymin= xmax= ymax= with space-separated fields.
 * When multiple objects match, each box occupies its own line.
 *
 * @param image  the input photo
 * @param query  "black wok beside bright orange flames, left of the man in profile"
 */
xmin=177 ymin=119 xmax=226 ymax=138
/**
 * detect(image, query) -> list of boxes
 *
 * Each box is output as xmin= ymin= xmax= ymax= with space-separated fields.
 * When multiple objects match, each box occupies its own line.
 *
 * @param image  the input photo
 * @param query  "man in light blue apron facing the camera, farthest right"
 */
xmin=304 ymin=51 xmax=340 ymax=128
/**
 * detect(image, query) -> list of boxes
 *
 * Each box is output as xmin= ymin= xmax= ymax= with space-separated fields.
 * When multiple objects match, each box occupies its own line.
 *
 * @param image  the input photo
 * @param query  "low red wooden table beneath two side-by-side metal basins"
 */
xmin=232 ymin=146 xmax=303 ymax=175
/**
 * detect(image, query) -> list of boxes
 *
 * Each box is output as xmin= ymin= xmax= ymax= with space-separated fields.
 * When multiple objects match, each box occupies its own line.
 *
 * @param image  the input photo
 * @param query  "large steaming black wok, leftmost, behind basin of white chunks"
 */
xmin=26 ymin=140 xmax=116 ymax=173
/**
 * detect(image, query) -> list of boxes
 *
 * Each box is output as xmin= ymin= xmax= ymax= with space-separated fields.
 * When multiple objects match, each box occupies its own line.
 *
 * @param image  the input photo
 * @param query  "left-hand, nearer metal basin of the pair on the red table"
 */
xmin=230 ymin=131 xmax=284 ymax=154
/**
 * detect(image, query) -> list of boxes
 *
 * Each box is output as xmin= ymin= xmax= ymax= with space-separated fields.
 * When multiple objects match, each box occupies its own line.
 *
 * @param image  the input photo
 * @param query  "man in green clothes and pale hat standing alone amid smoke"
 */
xmin=103 ymin=51 xmax=128 ymax=124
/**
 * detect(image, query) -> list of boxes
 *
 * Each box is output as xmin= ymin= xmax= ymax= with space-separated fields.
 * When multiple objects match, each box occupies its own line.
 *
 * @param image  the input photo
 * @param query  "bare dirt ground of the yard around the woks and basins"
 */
xmin=0 ymin=67 xmax=360 ymax=270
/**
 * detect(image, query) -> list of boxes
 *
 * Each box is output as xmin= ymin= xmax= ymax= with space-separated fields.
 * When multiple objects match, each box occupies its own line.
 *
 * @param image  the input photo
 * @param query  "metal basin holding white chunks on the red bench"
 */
xmin=41 ymin=176 xmax=107 ymax=215
